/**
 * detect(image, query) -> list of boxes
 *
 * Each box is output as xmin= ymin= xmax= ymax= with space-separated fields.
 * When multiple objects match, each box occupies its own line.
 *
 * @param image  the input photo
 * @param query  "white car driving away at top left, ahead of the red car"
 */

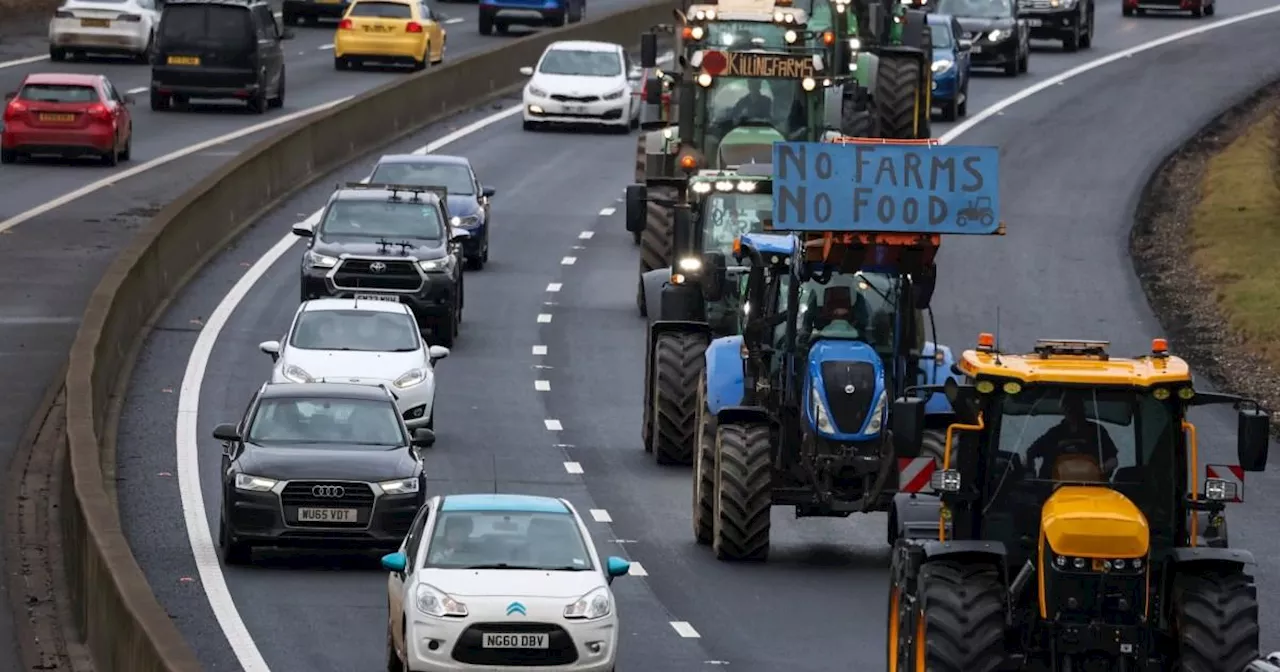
xmin=49 ymin=0 xmax=160 ymax=63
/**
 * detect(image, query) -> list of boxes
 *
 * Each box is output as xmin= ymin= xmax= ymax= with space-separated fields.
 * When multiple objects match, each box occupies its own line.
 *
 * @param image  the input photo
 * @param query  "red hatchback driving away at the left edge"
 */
xmin=0 ymin=73 xmax=133 ymax=165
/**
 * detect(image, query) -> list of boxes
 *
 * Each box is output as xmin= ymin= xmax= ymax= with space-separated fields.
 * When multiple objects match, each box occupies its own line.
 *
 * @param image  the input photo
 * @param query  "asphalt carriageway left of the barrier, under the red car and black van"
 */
xmin=0 ymin=0 xmax=660 ymax=672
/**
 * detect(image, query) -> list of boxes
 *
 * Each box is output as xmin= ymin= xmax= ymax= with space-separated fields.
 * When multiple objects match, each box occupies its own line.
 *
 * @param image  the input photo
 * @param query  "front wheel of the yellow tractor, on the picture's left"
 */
xmin=890 ymin=561 xmax=1009 ymax=672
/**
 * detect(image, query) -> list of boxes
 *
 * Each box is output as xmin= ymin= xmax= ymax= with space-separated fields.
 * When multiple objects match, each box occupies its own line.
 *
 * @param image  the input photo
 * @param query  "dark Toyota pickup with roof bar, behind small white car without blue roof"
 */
xmin=293 ymin=182 xmax=470 ymax=348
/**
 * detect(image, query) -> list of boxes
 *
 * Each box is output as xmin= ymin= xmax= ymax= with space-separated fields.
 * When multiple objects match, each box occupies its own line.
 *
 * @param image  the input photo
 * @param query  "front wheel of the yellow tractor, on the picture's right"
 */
xmin=1174 ymin=567 xmax=1258 ymax=672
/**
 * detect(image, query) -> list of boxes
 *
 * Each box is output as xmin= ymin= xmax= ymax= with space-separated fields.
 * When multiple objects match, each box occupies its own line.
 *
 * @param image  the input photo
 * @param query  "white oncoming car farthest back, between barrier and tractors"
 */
xmin=520 ymin=41 xmax=641 ymax=132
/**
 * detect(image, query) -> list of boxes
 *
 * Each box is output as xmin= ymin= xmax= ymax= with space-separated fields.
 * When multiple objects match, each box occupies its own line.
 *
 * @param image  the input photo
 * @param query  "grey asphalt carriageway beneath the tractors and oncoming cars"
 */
xmin=119 ymin=1 xmax=1280 ymax=672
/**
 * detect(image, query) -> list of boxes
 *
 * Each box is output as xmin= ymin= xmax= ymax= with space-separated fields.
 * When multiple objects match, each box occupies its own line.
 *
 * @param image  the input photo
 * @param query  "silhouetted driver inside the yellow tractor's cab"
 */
xmin=1027 ymin=392 xmax=1119 ymax=481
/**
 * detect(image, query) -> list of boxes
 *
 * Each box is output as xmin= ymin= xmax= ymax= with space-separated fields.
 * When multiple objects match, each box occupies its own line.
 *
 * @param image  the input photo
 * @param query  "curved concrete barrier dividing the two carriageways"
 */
xmin=61 ymin=1 xmax=676 ymax=672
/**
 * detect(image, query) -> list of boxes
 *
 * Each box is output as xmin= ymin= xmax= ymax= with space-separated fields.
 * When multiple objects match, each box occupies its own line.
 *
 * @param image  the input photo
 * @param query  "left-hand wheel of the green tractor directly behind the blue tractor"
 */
xmin=649 ymin=332 xmax=707 ymax=465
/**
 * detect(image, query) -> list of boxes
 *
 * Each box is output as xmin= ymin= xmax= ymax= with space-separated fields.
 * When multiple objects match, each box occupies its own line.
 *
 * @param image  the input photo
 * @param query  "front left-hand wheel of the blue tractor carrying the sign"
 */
xmin=712 ymin=422 xmax=773 ymax=561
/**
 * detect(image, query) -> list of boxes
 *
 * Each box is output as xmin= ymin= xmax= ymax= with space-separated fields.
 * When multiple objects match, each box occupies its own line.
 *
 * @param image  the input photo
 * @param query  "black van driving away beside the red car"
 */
xmin=151 ymin=0 xmax=293 ymax=114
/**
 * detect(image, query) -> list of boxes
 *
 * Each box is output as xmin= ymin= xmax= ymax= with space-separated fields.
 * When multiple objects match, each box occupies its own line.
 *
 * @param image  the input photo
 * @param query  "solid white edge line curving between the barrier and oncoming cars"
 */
xmin=176 ymin=99 xmax=524 ymax=672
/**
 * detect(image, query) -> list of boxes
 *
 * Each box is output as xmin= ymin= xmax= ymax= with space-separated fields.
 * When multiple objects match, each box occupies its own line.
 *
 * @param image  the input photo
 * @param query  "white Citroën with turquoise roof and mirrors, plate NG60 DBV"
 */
xmin=383 ymin=494 xmax=631 ymax=672
